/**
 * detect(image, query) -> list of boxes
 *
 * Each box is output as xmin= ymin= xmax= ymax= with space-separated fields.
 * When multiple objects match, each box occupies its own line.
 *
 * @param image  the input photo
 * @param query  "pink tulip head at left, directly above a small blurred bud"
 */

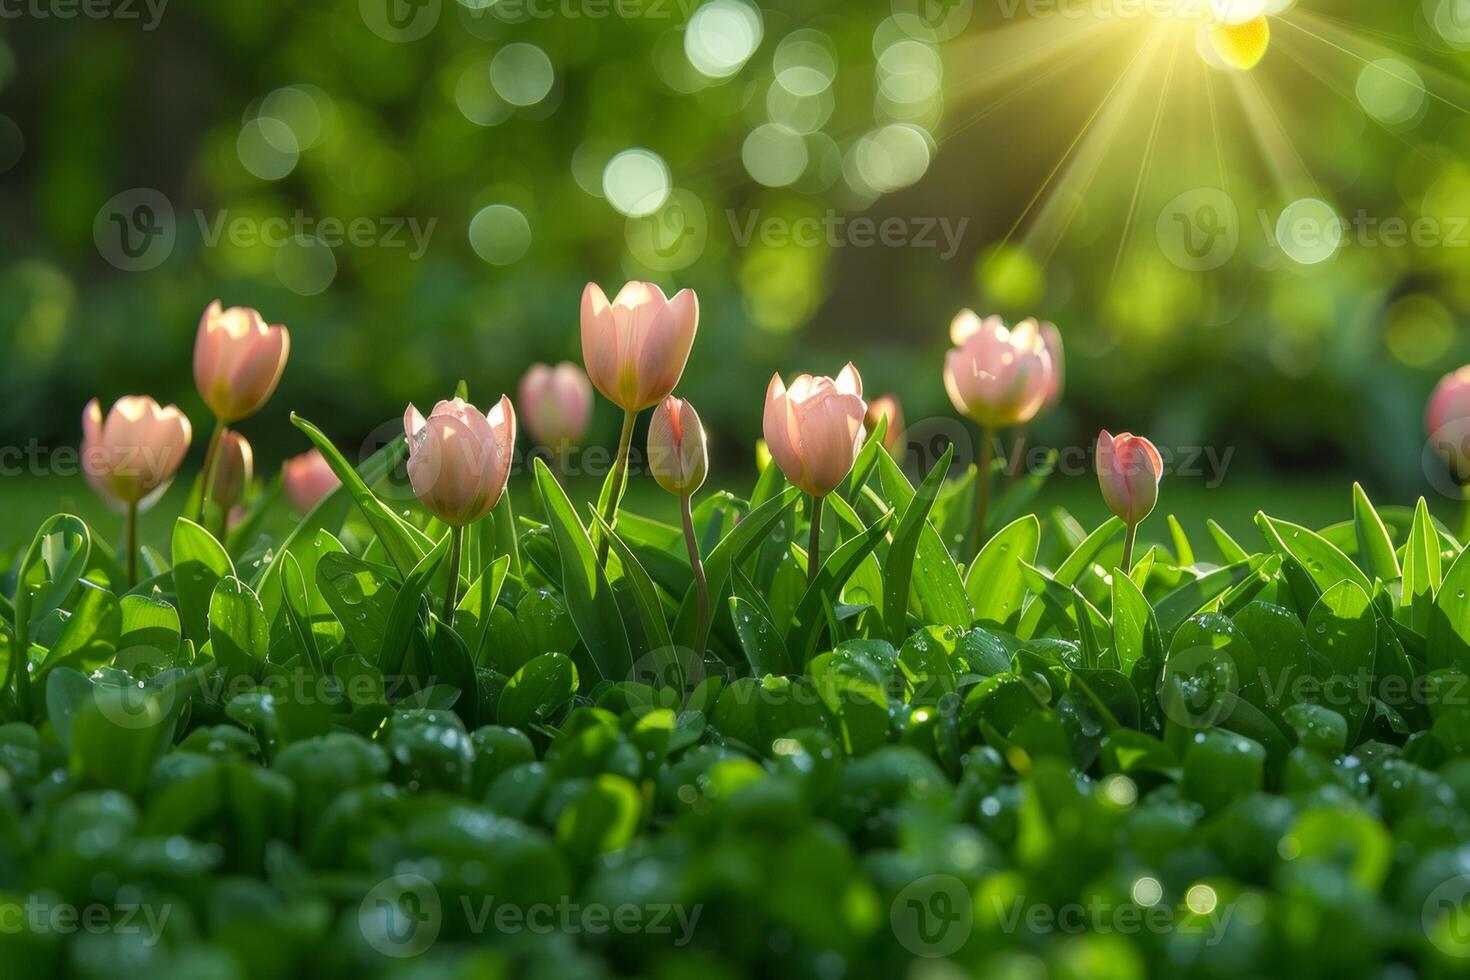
xmin=194 ymin=300 xmax=291 ymax=425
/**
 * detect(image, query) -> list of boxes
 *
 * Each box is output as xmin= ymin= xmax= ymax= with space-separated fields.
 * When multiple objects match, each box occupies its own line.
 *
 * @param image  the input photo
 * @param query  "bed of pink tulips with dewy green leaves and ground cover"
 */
xmin=0 ymin=284 xmax=1470 ymax=980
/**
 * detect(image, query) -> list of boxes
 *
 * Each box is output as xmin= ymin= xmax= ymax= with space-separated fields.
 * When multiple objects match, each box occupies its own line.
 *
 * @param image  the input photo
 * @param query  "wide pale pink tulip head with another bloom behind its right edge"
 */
xmin=944 ymin=310 xmax=1057 ymax=429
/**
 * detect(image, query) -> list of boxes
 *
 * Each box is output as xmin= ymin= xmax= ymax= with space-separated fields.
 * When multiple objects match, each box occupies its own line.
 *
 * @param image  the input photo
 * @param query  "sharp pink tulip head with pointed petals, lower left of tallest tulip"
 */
xmin=403 ymin=395 xmax=516 ymax=527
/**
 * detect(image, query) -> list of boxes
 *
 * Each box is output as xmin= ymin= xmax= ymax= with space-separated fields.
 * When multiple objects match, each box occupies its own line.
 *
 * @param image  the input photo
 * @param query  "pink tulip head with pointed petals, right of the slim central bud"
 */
xmin=764 ymin=364 xmax=867 ymax=497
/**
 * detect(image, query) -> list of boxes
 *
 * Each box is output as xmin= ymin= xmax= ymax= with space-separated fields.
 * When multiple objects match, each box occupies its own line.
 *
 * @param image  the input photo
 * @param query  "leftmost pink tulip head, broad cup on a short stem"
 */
xmin=82 ymin=395 xmax=191 ymax=510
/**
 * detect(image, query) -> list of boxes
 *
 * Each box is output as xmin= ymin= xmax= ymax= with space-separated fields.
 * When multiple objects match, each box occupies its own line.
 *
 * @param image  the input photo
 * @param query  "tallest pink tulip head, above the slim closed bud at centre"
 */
xmin=582 ymin=282 xmax=700 ymax=411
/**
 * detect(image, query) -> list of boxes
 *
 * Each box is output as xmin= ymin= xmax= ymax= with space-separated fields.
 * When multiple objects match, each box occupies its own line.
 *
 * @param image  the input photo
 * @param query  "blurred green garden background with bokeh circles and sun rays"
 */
xmin=0 ymin=0 xmax=1470 ymax=523
